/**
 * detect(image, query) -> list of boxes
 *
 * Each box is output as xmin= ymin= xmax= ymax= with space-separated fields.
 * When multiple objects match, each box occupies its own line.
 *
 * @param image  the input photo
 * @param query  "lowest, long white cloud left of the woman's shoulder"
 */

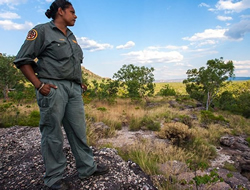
xmin=0 ymin=20 xmax=34 ymax=30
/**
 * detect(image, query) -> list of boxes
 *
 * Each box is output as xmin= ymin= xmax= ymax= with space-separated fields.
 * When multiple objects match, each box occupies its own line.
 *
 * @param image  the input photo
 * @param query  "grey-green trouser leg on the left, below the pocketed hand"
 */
xmin=37 ymin=81 xmax=66 ymax=186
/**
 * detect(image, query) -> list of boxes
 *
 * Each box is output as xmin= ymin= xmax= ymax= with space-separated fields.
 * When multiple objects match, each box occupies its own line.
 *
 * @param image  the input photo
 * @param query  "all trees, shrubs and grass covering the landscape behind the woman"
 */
xmin=0 ymin=55 xmax=250 ymax=189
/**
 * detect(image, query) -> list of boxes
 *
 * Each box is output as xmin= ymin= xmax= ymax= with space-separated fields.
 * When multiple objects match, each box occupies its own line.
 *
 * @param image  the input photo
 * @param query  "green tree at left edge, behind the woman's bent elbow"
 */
xmin=0 ymin=54 xmax=25 ymax=100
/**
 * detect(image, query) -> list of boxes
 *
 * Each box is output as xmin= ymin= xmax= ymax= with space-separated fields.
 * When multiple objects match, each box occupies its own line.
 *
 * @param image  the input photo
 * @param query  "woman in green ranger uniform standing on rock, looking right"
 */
xmin=14 ymin=0 xmax=109 ymax=189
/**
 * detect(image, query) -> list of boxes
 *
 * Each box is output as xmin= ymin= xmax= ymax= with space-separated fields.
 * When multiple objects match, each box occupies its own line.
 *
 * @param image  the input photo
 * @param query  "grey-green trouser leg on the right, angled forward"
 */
xmin=63 ymin=83 xmax=96 ymax=178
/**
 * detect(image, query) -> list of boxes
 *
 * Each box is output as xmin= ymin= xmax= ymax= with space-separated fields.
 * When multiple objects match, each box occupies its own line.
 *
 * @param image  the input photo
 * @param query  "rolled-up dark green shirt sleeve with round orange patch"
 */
xmin=14 ymin=26 xmax=44 ymax=68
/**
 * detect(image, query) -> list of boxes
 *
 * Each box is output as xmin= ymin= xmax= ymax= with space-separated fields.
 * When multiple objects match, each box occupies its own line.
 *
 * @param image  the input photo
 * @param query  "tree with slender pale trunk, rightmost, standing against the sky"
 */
xmin=183 ymin=58 xmax=234 ymax=110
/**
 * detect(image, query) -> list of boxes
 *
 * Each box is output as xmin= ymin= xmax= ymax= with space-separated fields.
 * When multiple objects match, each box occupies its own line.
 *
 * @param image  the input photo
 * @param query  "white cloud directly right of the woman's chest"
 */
xmin=77 ymin=37 xmax=113 ymax=52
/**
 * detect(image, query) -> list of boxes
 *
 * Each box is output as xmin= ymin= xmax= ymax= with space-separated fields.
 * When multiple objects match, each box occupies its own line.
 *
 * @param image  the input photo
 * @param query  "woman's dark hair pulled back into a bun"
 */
xmin=45 ymin=0 xmax=72 ymax=20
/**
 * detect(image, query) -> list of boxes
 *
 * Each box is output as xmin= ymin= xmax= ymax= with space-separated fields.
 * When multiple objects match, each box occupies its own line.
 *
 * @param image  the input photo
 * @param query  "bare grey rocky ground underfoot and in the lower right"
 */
xmin=0 ymin=126 xmax=250 ymax=190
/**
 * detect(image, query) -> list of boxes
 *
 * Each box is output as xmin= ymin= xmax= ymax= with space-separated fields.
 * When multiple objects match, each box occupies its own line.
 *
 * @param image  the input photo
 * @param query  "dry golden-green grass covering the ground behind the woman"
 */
xmin=0 ymin=83 xmax=250 ymax=189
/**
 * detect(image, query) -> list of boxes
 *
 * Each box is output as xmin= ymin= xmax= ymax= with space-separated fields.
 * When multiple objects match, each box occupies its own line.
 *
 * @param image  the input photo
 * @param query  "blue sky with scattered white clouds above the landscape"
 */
xmin=0 ymin=0 xmax=250 ymax=80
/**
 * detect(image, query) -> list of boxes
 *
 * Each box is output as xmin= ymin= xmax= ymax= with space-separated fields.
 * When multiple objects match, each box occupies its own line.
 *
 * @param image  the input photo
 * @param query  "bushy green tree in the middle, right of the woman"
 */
xmin=113 ymin=64 xmax=155 ymax=99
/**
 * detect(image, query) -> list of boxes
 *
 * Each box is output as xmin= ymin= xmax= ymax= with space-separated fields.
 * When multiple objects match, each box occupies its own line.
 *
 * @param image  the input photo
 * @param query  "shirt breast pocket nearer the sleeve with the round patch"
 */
xmin=51 ymin=41 xmax=72 ymax=61
